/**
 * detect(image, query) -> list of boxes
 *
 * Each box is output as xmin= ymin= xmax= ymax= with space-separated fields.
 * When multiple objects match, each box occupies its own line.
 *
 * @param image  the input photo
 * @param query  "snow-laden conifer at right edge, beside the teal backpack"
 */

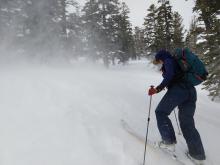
xmin=195 ymin=0 xmax=220 ymax=99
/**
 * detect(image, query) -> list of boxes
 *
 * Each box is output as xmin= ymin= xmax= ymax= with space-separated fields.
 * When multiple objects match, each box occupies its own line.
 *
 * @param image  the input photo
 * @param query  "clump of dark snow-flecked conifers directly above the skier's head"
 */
xmin=144 ymin=0 xmax=184 ymax=54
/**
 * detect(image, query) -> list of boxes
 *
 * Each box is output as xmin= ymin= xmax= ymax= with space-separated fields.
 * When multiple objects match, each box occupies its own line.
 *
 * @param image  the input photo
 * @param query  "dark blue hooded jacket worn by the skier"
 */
xmin=155 ymin=50 xmax=181 ymax=91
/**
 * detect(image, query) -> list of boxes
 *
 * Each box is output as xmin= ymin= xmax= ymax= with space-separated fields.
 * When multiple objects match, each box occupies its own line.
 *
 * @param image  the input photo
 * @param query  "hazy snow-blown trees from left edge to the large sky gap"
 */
xmin=0 ymin=0 xmax=135 ymax=65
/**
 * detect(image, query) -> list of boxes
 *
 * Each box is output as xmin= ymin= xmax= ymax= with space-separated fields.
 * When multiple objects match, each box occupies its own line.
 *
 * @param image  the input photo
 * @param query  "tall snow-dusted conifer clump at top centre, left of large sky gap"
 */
xmin=83 ymin=0 xmax=135 ymax=66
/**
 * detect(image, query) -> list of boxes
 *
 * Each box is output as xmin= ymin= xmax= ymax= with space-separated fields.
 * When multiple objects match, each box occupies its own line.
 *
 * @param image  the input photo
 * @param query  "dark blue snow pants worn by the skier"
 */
xmin=156 ymin=84 xmax=205 ymax=160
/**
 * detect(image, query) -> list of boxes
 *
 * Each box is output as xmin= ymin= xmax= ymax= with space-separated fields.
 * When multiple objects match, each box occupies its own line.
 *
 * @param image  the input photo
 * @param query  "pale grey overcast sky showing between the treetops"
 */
xmin=78 ymin=0 xmax=194 ymax=29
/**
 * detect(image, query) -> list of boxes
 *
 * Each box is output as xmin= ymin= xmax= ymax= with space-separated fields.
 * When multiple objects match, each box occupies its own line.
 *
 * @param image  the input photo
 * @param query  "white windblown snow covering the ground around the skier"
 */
xmin=0 ymin=61 xmax=220 ymax=165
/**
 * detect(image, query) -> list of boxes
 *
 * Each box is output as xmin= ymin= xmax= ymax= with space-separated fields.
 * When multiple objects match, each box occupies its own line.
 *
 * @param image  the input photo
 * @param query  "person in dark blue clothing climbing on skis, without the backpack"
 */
xmin=148 ymin=50 xmax=206 ymax=162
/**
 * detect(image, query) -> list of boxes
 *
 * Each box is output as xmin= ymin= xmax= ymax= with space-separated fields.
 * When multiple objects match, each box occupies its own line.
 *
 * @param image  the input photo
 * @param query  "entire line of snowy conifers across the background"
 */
xmin=0 ymin=0 xmax=220 ymax=97
